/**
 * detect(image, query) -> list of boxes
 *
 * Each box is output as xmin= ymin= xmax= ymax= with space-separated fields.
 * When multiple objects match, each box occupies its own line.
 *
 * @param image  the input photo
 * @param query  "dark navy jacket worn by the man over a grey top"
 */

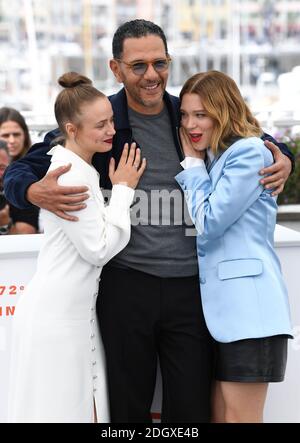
xmin=4 ymin=88 xmax=294 ymax=208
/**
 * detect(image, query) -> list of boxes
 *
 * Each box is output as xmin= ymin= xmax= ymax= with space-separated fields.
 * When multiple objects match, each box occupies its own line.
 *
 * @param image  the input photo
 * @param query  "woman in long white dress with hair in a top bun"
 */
xmin=8 ymin=73 xmax=146 ymax=423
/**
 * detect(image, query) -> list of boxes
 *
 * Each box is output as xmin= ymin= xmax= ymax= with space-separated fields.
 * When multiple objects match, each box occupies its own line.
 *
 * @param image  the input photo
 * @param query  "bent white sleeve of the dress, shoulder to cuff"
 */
xmin=59 ymin=169 xmax=134 ymax=266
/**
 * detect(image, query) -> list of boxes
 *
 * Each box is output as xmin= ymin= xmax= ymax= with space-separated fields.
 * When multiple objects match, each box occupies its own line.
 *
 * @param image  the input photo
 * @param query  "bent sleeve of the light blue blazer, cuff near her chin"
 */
xmin=175 ymin=143 xmax=271 ymax=240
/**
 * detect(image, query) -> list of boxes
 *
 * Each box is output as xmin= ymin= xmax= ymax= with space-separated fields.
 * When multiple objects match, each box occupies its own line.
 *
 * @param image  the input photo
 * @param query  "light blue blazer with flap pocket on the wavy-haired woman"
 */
xmin=175 ymin=137 xmax=292 ymax=343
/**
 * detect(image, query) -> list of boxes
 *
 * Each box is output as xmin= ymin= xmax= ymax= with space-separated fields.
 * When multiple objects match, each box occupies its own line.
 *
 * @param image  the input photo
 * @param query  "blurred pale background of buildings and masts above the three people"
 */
xmin=0 ymin=0 xmax=300 ymax=114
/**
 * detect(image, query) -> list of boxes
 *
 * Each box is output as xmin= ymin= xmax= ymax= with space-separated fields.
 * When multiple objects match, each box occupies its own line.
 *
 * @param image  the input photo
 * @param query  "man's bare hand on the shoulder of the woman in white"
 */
xmin=26 ymin=165 xmax=89 ymax=221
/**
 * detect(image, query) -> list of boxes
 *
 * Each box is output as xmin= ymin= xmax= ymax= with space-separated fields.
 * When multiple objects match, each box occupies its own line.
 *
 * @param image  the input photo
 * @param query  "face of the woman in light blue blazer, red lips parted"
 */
xmin=180 ymin=93 xmax=215 ymax=151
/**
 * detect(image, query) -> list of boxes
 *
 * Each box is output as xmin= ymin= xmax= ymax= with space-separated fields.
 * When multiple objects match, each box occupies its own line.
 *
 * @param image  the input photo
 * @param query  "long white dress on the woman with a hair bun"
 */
xmin=8 ymin=146 xmax=134 ymax=423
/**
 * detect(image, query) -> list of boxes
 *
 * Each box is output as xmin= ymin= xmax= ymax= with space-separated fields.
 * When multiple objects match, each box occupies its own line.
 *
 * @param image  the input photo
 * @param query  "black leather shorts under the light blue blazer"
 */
xmin=215 ymin=335 xmax=289 ymax=383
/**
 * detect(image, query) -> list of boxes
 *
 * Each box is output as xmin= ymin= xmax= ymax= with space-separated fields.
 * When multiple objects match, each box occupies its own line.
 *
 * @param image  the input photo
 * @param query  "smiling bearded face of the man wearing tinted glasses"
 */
xmin=110 ymin=35 xmax=168 ymax=114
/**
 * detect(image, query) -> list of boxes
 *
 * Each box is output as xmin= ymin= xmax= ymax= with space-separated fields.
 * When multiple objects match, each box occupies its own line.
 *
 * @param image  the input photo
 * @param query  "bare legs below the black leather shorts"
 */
xmin=213 ymin=382 xmax=268 ymax=423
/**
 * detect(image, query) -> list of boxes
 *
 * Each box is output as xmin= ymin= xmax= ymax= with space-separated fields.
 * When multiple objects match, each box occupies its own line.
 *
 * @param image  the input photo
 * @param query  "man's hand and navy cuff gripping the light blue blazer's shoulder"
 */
xmin=260 ymin=134 xmax=295 ymax=196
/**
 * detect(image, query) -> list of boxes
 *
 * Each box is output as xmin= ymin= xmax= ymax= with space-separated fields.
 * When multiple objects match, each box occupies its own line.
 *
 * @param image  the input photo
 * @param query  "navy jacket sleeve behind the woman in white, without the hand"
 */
xmin=4 ymin=129 xmax=60 ymax=209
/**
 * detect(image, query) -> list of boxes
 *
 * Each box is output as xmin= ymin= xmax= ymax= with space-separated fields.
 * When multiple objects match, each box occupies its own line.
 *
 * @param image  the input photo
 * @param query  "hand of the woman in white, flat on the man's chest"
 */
xmin=109 ymin=143 xmax=146 ymax=189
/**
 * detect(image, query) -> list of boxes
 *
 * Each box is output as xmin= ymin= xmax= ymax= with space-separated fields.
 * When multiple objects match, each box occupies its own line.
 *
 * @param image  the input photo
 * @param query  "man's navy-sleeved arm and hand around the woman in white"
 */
xmin=4 ymin=129 xmax=88 ymax=221
